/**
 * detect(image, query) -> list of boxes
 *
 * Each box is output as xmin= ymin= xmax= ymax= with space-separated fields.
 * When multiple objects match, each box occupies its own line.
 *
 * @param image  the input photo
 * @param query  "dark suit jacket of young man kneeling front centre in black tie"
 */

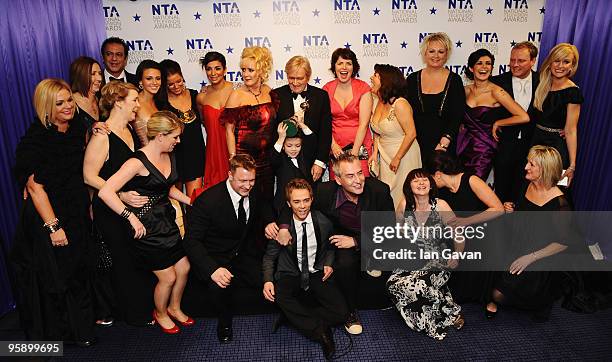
xmin=262 ymin=211 xmax=334 ymax=283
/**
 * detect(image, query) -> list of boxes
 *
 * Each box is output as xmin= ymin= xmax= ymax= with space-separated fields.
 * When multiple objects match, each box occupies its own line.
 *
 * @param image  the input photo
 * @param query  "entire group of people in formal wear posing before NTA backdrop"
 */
xmin=11 ymin=33 xmax=583 ymax=357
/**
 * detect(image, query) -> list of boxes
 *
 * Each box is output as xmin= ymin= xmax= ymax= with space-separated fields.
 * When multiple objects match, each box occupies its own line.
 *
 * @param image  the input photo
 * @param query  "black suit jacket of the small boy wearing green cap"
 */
xmin=270 ymin=148 xmax=314 ymax=212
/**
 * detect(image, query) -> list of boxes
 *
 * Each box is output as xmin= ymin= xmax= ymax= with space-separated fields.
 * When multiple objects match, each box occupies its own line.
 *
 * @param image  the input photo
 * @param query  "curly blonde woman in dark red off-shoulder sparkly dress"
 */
xmin=220 ymin=46 xmax=279 ymax=202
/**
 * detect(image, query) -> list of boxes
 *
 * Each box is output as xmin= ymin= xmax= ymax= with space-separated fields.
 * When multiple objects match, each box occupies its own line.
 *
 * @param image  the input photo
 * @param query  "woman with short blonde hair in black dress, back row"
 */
xmin=406 ymin=33 xmax=465 ymax=165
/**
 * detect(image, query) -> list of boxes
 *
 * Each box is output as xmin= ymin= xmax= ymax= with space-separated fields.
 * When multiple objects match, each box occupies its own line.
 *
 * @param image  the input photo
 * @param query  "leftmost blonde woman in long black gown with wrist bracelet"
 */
xmin=11 ymin=79 xmax=95 ymax=346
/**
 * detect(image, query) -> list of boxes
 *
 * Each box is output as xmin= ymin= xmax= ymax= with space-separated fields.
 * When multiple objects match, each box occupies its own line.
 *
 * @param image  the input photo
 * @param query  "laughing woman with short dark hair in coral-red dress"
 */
xmin=323 ymin=48 xmax=372 ymax=179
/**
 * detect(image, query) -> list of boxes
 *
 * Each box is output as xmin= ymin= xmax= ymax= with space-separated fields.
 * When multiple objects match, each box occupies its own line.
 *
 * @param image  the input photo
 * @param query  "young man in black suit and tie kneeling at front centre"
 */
xmin=262 ymin=179 xmax=348 ymax=359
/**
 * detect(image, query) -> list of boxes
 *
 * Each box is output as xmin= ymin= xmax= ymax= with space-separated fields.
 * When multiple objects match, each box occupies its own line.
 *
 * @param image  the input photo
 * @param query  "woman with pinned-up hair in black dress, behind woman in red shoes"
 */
xmin=83 ymin=81 xmax=154 ymax=325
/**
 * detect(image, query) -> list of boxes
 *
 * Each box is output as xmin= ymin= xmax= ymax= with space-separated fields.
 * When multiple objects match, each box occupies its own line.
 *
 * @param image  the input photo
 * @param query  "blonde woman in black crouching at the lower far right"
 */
xmin=486 ymin=146 xmax=571 ymax=319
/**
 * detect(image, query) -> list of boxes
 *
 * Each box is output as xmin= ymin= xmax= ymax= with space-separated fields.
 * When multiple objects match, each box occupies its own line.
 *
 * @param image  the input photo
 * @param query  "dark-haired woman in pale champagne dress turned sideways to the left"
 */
xmin=369 ymin=64 xmax=421 ymax=207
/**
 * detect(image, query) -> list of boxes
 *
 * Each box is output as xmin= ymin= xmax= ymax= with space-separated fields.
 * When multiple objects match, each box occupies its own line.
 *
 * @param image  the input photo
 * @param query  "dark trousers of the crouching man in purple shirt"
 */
xmin=334 ymin=248 xmax=361 ymax=312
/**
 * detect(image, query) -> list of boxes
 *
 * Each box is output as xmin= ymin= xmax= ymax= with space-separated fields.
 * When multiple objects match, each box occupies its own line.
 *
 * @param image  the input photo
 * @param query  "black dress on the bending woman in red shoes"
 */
xmin=125 ymin=150 xmax=185 ymax=270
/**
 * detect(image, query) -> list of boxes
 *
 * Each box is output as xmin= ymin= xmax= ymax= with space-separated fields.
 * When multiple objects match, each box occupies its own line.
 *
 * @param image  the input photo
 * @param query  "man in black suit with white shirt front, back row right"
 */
xmin=492 ymin=41 xmax=540 ymax=202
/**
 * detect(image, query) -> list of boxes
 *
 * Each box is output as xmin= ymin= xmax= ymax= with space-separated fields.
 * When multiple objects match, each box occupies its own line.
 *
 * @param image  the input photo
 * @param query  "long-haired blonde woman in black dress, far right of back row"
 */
xmin=532 ymin=43 xmax=584 ymax=185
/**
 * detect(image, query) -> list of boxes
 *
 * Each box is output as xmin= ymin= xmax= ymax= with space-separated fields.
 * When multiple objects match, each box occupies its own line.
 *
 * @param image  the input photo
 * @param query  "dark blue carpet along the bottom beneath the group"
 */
xmin=57 ymin=304 xmax=612 ymax=361
